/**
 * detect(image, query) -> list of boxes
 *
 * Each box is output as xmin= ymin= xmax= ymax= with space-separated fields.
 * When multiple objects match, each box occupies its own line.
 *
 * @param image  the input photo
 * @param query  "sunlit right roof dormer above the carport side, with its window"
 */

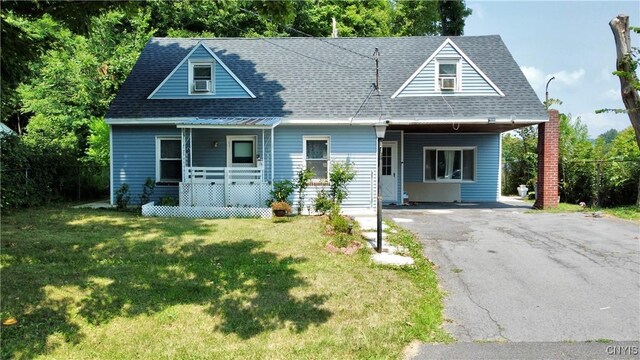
xmin=391 ymin=38 xmax=504 ymax=99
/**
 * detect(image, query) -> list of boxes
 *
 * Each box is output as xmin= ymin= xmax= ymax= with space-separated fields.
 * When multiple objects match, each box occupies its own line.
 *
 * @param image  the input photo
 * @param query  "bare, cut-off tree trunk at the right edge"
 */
xmin=609 ymin=14 xmax=640 ymax=206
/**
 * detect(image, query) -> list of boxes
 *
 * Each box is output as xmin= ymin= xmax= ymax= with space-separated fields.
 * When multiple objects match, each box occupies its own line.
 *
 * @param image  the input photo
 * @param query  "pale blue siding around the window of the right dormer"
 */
xmin=398 ymin=45 xmax=499 ymax=97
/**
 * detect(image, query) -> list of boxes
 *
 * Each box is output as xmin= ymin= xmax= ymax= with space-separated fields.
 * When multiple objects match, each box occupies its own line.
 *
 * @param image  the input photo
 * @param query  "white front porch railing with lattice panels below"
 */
xmin=180 ymin=167 xmax=271 ymax=208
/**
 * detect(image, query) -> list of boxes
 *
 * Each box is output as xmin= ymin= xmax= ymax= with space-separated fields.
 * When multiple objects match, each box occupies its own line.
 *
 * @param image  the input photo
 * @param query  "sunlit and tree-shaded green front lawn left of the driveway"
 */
xmin=0 ymin=209 xmax=450 ymax=359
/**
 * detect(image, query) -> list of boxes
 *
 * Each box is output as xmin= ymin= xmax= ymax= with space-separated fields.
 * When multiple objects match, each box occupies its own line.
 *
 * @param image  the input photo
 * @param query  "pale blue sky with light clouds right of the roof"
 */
xmin=464 ymin=0 xmax=640 ymax=138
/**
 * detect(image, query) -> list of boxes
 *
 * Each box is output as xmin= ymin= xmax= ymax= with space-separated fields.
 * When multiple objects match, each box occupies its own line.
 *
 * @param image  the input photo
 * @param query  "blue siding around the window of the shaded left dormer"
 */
xmin=151 ymin=46 xmax=250 ymax=99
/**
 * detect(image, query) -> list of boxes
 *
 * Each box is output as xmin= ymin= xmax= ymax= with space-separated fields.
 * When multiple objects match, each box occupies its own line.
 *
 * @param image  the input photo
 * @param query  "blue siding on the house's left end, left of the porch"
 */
xmin=111 ymin=125 xmax=180 ymax=204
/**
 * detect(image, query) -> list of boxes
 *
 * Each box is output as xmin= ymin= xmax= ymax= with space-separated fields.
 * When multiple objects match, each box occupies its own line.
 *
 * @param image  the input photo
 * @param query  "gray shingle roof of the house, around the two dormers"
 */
xmin=107 ymin=35 xmax=547 ymax=120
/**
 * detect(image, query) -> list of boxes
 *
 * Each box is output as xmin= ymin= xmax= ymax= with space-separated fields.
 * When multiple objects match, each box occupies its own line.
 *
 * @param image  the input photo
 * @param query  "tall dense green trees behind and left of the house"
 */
xmin=0 ymin=0 xmax=476 ymax=206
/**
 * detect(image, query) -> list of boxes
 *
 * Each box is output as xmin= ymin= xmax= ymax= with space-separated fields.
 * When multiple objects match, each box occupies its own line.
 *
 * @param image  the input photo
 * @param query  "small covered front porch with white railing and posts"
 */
xmin=178 ymin=118 xmax=280 ymax=208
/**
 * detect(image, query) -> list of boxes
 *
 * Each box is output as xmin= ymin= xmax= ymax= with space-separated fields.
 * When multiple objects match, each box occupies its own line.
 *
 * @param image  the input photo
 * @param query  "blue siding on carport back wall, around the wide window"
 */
xmin=404 ymin=133 xmax=500 ymax=202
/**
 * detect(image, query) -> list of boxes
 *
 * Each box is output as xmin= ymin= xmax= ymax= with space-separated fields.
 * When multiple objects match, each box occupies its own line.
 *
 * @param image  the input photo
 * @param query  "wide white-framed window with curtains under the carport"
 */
xmin=423 ymin=147 xmax=476 ymax=182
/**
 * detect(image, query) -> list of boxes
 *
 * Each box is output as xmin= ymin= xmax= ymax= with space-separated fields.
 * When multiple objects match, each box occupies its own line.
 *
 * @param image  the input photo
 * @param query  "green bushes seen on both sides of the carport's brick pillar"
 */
xmin=502 ymin=114 xmax=640 ymax=206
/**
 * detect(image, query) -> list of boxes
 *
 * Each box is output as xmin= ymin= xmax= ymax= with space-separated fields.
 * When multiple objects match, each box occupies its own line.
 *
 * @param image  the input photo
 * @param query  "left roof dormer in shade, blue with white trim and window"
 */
xmin=147 ymin=42 xmax=256 ymax=99
